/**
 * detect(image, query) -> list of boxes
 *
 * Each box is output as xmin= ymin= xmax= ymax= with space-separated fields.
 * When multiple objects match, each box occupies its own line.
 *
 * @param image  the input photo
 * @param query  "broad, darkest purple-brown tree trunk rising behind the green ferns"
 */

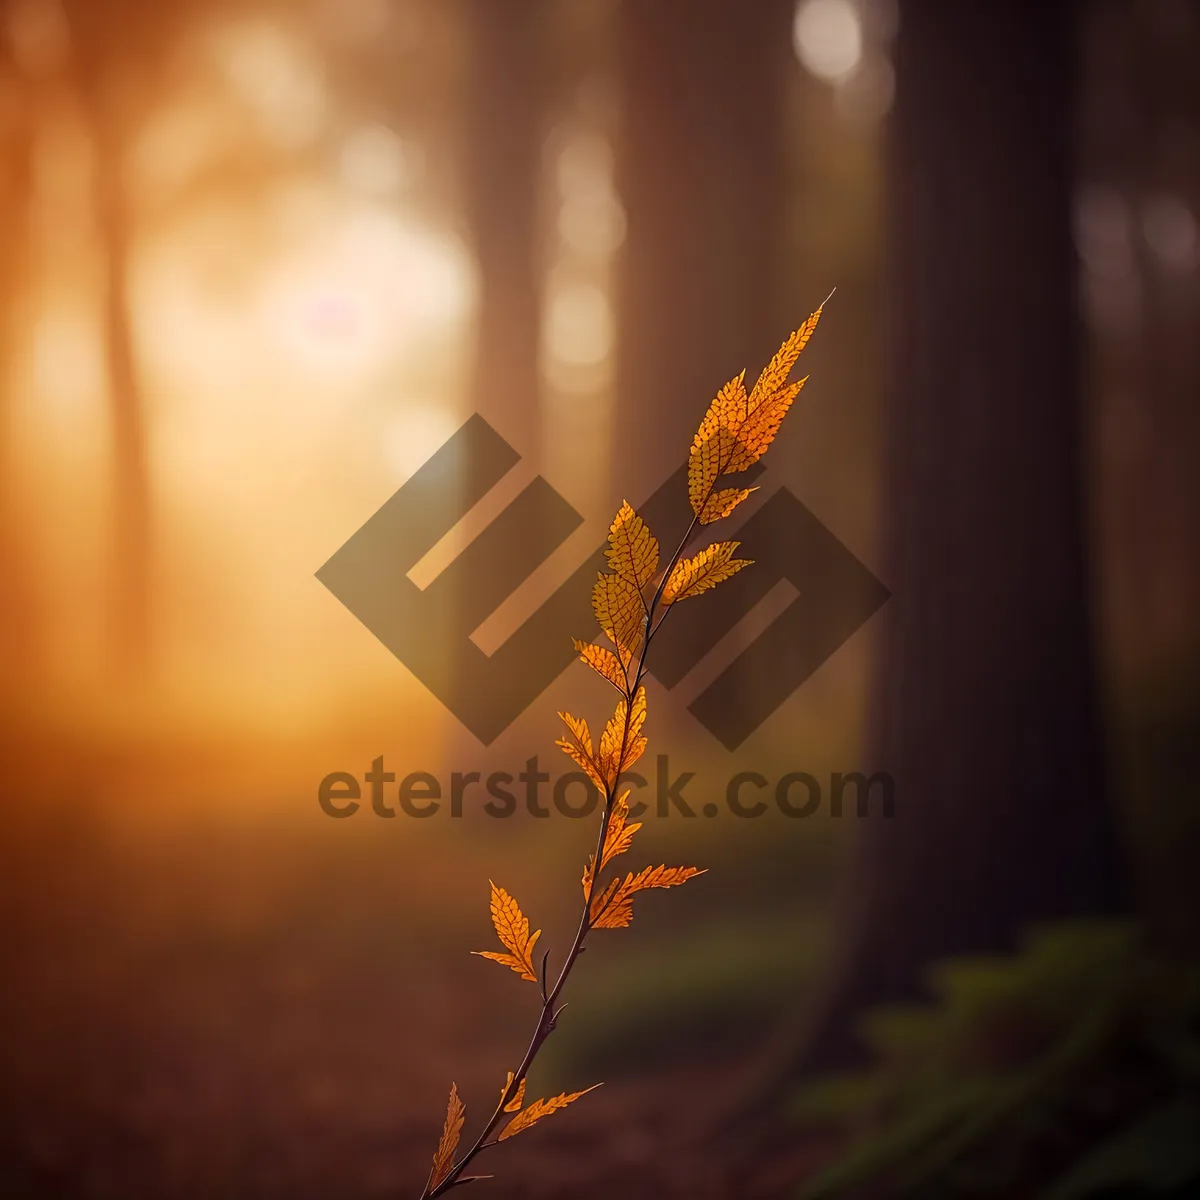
xmin=793 ymin=0 xmax=1120 ymax=1070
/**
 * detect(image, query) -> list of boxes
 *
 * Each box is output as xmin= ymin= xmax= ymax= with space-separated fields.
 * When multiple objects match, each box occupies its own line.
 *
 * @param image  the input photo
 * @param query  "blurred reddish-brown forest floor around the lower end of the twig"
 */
xmin=0 ymin=806 xmax=835 ymax=1200
